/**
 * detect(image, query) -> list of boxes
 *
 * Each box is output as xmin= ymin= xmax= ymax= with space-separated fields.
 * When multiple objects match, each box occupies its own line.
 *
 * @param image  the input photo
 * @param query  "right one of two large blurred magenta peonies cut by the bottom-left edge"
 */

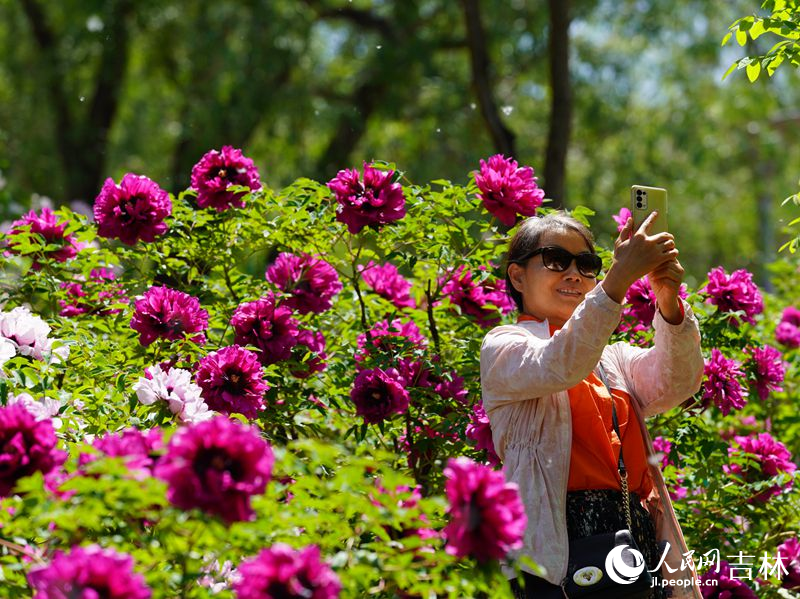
xmin=234 ymin=543 xmax=342 ymax=599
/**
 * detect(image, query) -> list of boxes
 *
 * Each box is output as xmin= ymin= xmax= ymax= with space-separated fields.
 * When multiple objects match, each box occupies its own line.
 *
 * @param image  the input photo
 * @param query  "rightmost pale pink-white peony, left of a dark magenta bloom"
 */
xmin=133 ymin=365 xmax=214 ymax=423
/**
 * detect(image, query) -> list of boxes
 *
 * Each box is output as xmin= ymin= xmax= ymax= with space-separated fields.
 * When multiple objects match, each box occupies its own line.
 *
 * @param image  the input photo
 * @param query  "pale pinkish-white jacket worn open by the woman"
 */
xmin=481 ymin=285 xmax=703 ymax=598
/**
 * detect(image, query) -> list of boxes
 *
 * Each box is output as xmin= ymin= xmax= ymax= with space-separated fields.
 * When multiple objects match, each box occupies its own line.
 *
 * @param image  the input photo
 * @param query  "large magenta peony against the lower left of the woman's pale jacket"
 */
xmin=444 ymin=457 xmax=527 ymax=562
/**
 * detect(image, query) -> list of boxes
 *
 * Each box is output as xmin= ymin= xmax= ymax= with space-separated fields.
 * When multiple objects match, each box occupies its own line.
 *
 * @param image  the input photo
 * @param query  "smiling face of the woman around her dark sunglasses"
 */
xmin=508 ymin=229 xmax=597 ymax=327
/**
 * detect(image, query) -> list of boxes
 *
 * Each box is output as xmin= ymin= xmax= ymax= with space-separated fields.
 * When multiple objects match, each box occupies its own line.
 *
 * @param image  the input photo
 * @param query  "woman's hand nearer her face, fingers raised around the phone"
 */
xmin=602 ymin=212 xmax=683 ymax=304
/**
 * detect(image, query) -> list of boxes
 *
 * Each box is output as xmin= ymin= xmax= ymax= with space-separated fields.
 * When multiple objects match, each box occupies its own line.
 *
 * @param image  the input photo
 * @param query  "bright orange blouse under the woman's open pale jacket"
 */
xmin=517 ymin=314 xmax=653 ymax=498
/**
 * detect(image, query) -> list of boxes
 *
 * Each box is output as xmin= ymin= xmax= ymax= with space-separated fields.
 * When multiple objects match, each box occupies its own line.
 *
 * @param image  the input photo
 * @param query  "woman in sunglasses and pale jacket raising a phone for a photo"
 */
xmin=481 ymin=213 xmax=703 ymax=598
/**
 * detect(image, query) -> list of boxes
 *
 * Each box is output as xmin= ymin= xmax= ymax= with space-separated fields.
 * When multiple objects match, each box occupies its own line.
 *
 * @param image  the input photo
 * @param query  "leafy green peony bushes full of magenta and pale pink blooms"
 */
xmin=0 ymin=151 xmax=800 ymax=599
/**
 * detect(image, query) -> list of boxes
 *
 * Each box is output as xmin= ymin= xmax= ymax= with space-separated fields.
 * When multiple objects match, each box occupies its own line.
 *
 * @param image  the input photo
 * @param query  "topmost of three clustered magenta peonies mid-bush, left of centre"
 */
xmin=267 ymin=252 xmax=342 ymax=314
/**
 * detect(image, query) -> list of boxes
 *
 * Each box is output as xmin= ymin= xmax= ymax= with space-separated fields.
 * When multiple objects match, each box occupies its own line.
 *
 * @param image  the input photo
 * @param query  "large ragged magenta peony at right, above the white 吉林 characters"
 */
xmin=725 ymin=433 xmax=797 ymax=502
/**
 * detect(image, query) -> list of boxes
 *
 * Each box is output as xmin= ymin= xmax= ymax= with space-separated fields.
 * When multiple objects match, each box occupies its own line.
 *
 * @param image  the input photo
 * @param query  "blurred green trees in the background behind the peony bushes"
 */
xmin=0 ymin=0 xmax=800 ymax=285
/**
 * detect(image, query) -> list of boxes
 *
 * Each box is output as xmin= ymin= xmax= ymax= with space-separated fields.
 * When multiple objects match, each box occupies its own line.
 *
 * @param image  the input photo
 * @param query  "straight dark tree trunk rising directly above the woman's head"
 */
xmin=543 ymin=0 xmax=572 ymax=207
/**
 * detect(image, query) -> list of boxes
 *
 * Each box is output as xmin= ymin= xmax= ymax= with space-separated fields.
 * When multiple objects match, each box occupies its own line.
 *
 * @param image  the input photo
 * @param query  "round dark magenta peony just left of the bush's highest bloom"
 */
xmin=94 ymin=173 xmax=172 ymax=245
